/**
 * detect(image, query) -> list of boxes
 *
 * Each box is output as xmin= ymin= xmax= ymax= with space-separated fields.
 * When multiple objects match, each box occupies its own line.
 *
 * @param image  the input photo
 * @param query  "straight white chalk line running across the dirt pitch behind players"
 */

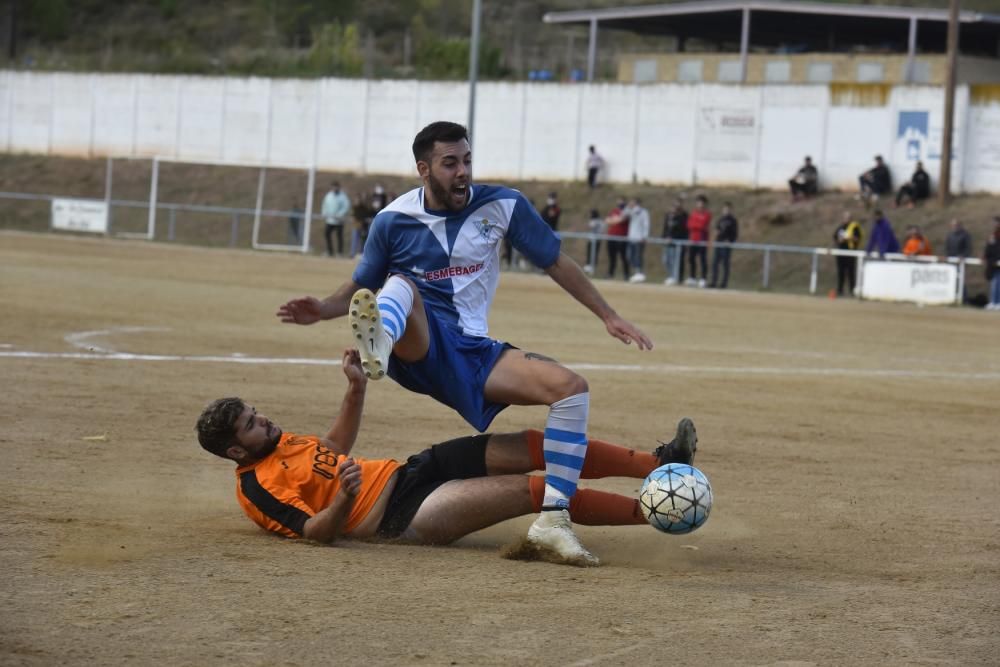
xmin=0 ymin=351 xmax=1000 ymax=381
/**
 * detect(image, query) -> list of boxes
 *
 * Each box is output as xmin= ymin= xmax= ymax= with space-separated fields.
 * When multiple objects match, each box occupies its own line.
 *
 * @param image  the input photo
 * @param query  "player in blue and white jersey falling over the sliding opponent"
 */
xmin=277 ymin=121 xmax=696 ymax=566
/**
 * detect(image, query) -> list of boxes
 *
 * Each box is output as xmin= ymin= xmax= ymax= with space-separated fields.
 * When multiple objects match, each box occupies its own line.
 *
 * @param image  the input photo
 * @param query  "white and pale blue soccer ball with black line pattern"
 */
xmin=639 ymin=463 xmax=712 ymax=535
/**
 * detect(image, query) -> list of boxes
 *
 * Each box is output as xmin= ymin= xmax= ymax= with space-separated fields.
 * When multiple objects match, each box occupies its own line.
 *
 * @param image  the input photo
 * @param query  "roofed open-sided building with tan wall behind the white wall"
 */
xmin=543 ymin=0 xmax=1000 ymax=85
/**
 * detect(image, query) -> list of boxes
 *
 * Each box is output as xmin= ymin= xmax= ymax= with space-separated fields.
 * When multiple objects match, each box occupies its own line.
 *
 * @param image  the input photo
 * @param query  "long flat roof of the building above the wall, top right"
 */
xmin=542 ymin=0 xmax=1000 ymax=79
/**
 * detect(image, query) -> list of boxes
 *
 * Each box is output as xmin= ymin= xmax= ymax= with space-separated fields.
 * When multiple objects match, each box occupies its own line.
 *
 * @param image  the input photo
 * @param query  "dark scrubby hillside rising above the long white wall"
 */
xmin=7 ymin=0 xmax=1000 ymax=79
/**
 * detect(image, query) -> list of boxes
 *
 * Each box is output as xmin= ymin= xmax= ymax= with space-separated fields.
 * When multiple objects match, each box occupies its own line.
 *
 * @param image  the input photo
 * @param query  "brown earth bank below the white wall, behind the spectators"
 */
xmin=0 ymin=155 xmax=1000 ymax=302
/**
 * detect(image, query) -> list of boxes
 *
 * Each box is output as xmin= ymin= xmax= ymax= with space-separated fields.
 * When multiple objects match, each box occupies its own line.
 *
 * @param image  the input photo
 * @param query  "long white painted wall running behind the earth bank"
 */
xmin=0 ymin=71 xmax=1000 ymax=193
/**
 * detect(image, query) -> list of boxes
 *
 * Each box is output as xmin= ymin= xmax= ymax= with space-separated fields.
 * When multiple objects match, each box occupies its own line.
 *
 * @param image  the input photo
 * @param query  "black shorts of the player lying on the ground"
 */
xmin=375 ymin=433 xmax=490 ymax=538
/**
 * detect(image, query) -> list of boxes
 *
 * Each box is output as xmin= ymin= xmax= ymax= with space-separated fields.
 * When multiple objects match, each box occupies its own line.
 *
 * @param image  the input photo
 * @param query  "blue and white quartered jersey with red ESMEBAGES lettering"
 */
xmin=353 ymin=185 xmax=560 ymax=336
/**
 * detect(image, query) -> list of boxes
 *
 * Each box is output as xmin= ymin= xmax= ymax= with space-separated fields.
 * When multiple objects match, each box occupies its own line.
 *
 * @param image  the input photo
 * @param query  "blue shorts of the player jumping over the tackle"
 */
xmin=389 ymin=303 xmax=514 ymax=433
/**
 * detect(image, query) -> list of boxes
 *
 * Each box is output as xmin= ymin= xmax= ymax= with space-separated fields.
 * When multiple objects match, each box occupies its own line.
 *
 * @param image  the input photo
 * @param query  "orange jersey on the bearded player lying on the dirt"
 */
xmin=236 ymin=433 xmax=401 ymax=537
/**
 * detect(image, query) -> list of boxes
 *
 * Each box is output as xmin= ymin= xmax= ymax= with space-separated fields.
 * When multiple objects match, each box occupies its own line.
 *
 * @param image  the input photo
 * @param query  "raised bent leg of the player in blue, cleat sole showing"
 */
xmin=349 ymin=275 xmax=430 ymax=380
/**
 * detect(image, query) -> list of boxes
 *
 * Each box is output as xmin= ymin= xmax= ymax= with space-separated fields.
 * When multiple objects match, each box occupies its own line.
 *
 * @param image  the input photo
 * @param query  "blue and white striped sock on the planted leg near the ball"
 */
xmin=542 ymin=392 xmax=590 ymax=509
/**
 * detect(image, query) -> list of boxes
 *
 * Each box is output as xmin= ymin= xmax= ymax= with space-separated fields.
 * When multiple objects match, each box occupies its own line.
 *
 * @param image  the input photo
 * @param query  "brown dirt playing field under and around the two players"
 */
xmin=0 ymin=232 xmax=1000 ymax=667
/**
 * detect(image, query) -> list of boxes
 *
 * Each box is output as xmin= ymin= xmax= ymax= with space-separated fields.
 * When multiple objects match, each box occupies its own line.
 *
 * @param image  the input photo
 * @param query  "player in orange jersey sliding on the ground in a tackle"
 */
xmin=196 ymin=349 xmax=697 ymax=564
